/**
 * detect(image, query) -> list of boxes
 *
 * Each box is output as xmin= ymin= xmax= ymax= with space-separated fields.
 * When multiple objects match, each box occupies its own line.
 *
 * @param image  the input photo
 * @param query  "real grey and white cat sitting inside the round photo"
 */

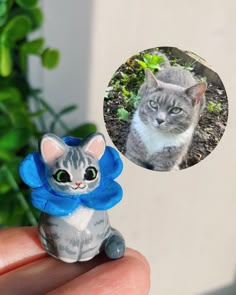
xmin=126 ymin=65 xmax=207 ymax=171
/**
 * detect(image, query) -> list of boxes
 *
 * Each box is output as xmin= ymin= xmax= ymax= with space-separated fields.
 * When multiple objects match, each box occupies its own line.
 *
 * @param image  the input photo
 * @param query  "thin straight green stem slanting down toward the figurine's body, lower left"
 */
xmin=1 ymin=165 xmax=37 ymax=225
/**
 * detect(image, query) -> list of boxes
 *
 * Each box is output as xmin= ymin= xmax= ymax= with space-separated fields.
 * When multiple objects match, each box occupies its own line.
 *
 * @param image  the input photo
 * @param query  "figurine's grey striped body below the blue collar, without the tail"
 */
xmin=39 ymin=209 xmax=113 ymax=262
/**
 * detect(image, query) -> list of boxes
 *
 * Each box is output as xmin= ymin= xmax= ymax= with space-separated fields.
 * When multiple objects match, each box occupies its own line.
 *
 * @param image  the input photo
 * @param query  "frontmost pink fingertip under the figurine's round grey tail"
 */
xmin=50 ymin=249 xmax=150 ymax=295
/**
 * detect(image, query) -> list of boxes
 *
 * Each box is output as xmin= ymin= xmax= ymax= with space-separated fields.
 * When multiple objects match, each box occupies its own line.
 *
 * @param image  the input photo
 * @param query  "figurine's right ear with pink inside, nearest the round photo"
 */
xmin=83 ymin=133 xmax=106 ymax=160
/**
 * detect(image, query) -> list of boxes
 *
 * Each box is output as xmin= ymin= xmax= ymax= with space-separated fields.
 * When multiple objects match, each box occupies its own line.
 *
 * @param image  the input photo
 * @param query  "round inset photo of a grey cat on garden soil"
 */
xmin=104 ymin=47 xmax=228 ymax=171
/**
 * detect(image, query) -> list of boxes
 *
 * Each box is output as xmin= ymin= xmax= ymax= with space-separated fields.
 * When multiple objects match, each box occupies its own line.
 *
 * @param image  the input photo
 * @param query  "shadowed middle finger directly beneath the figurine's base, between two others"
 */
xmin=0 ymin=255 xmax=107 ymax=295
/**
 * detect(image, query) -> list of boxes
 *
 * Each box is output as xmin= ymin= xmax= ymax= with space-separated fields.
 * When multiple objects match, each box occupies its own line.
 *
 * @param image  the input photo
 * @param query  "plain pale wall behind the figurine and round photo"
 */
xmin=32 ymin=0 xmax=236 ymax=295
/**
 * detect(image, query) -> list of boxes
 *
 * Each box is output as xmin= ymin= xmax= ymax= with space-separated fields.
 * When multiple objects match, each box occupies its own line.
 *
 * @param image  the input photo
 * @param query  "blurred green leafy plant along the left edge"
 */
xmin=0 ymin=0 xmax=96 ymax=227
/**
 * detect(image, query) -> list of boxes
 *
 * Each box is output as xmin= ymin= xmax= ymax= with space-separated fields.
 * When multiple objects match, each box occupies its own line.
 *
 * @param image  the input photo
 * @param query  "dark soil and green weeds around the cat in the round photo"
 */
xmin=104 ymin=47 xmax=228 ymax=169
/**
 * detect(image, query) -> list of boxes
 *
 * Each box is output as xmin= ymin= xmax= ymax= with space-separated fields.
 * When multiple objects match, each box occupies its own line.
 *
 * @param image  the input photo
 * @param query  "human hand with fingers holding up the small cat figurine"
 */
xmin=0 ymin=227 xmax=150 ymax=295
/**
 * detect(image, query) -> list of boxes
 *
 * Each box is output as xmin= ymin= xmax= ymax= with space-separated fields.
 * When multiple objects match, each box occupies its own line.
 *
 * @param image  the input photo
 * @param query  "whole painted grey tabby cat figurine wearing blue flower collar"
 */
xmin=20 ymin=133 xmax=125 ymax=262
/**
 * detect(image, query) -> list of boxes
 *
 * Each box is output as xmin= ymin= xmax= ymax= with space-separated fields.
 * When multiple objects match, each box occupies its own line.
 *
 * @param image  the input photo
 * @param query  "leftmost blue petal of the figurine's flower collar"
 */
xmin=19 ymin=152 xmax=44 ymax=188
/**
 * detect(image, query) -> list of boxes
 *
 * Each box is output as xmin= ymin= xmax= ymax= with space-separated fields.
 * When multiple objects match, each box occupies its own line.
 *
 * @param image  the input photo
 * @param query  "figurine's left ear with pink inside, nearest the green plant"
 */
xmin=39 ymin=133 xmax=68 ymax=164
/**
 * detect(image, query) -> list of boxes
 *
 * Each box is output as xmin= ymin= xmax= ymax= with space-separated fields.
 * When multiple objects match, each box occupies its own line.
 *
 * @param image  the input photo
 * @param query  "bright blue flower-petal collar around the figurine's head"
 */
xmin=19 ymin=137 xmax=123 ymax=216
